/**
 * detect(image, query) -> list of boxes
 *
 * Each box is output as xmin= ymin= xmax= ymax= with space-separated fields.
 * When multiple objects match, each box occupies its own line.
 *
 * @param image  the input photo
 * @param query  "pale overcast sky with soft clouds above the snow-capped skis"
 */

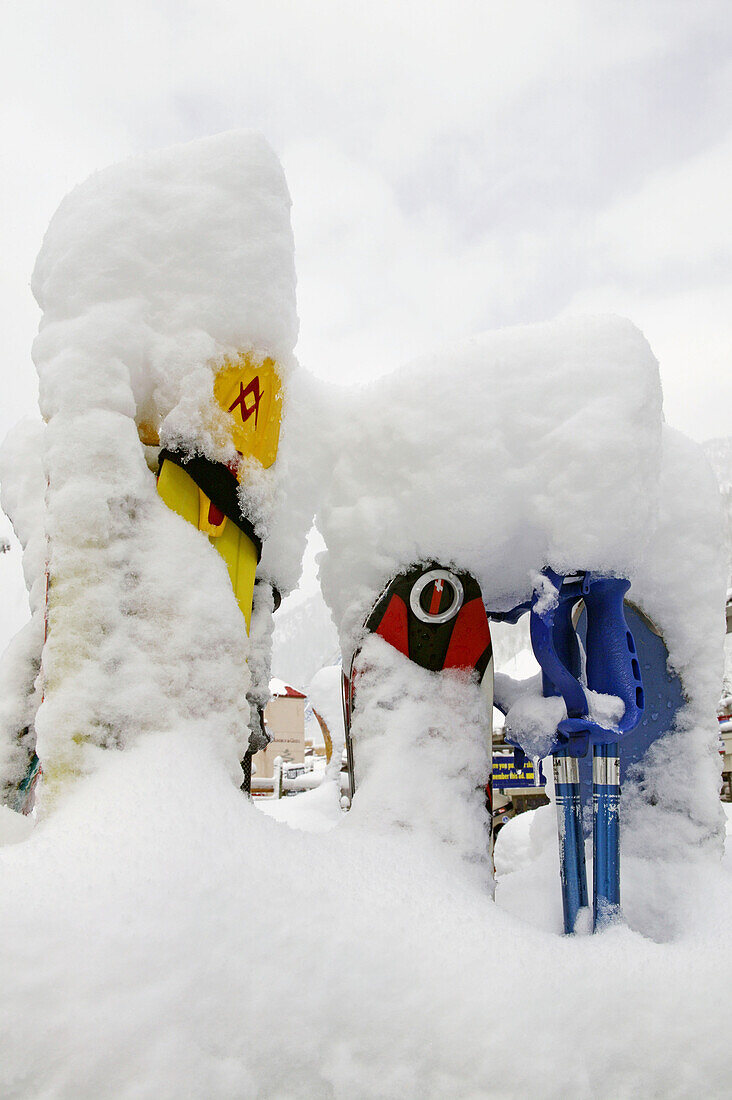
xmin=0 ymin=0 xmax=732 ymax=451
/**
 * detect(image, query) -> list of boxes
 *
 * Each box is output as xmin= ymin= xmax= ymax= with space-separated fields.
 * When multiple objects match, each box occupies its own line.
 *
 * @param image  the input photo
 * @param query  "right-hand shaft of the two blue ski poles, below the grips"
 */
xmin=592 ymin=745 xmax=620 ymax=930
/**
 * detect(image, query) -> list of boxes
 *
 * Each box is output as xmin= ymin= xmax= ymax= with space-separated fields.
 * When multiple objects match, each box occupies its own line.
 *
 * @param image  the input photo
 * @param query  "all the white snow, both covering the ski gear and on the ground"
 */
xmin=0 ymin=133 xmax=732 ymax=1100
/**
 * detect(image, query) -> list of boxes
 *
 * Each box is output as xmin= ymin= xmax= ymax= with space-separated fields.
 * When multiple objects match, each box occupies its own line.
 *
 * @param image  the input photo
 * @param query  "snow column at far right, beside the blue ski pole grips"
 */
xmin=623 ymin=428 xmax=724 ymax=880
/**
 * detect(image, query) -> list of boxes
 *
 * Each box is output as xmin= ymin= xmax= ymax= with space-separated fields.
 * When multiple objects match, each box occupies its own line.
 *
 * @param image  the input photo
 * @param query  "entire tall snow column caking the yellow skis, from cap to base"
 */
xmin=3 ymin=132 xmax=313 ymax=814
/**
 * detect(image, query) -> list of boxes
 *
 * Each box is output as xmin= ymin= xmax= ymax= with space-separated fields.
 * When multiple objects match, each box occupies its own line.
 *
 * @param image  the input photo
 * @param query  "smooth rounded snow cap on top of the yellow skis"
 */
xmin=33 ymin=132 xmax=297 ymax=431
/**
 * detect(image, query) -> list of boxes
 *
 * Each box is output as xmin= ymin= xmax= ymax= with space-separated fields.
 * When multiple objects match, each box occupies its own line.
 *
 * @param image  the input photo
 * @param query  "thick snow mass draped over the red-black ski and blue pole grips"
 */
xmin=316 ymin=317 xmax=724 ymax=897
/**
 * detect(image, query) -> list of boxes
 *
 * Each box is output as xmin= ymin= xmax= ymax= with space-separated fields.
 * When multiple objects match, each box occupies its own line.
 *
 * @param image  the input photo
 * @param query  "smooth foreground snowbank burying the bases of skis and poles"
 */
xmin=0 ymin=736 xmax=732 ymax=1098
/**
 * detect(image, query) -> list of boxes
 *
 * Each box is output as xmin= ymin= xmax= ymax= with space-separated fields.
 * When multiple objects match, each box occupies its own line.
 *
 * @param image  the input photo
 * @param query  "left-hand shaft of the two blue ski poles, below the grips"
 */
xmin=554 ymin=749 xmax=588 ymax=935
